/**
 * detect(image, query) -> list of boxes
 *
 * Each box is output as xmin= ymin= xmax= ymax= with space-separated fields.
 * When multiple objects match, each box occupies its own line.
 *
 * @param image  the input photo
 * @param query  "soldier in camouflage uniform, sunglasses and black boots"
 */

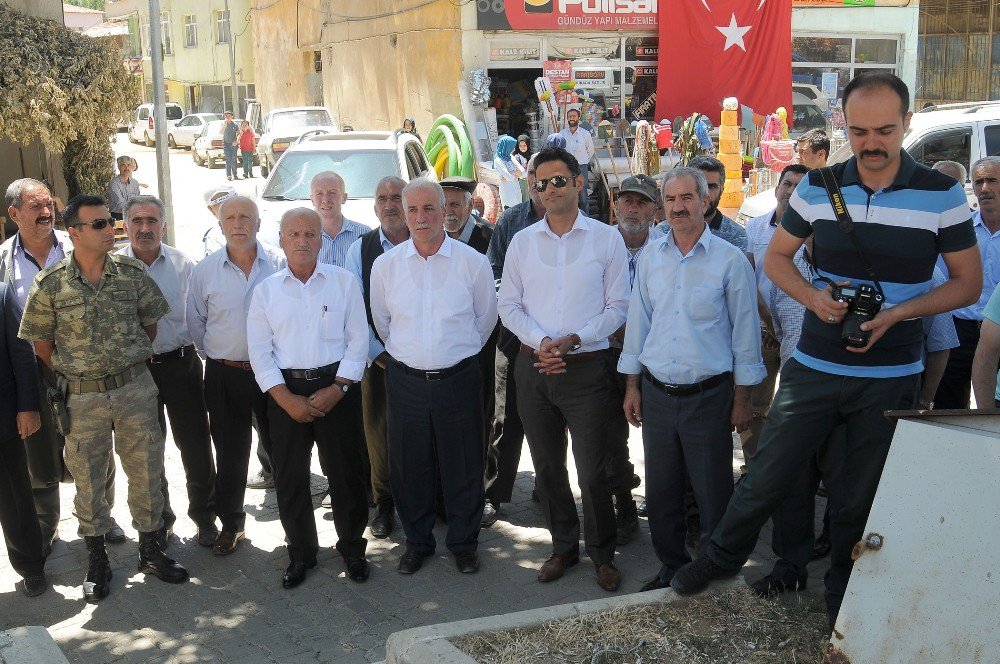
xmin=18 ymin=196 xmax=188 ymax=601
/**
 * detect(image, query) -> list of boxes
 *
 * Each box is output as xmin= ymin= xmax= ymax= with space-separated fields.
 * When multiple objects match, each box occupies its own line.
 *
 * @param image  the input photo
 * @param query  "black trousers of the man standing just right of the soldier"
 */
xmin=146 ymin=346 xmax=215 ymax=527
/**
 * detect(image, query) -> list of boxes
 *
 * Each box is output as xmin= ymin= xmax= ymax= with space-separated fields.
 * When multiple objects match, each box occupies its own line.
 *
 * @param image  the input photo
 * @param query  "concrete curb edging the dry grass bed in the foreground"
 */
xmin=385 ymin=575 xmax=745 ymax=664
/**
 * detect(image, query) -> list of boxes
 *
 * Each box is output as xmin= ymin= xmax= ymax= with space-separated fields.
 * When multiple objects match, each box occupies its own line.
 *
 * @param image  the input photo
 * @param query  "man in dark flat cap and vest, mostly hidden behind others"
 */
xmin=440 ymin=175 xmax=500 ymax=528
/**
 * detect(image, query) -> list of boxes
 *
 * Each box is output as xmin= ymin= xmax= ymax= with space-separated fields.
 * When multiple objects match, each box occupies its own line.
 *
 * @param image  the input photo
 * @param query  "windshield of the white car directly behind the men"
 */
xmin=261 ymin=150 xmax=400 ymax=201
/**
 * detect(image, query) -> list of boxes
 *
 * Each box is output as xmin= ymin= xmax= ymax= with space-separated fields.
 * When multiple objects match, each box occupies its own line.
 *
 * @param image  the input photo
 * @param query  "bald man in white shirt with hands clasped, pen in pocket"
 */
xmin=247 ymin=208 xmax=369 ymax=588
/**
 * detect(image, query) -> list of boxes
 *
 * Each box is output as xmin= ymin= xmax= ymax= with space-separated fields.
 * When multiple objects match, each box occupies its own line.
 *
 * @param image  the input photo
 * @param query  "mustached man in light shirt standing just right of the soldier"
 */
xmin=118 ymin=195 xmax=219 ymax=549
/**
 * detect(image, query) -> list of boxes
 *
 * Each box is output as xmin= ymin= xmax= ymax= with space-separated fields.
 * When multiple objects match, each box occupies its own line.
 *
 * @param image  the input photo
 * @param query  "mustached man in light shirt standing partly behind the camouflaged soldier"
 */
xmin=0 ymin=178 xmax=125 ymax=556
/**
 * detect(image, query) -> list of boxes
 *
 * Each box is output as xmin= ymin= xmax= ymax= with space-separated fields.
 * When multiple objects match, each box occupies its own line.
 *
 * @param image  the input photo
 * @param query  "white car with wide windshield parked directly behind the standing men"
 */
xmin=257 ymin=131 xmax=437 ymax=246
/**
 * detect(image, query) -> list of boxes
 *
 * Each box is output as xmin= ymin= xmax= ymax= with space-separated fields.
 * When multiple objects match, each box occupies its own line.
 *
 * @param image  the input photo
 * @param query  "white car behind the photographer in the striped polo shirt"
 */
xmin=739 ymin=101 xmax=1000 ymax=225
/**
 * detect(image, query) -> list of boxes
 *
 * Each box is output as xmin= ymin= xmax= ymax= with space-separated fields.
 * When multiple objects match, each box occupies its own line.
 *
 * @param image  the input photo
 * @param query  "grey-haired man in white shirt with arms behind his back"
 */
xmin=370 ymin=178 xmax=497 ymax=574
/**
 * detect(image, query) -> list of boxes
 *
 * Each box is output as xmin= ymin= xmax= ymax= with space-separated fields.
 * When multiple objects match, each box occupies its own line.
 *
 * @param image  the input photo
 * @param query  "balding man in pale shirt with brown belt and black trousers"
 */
xmin=186 ymin=196 xmax=285 ymax=556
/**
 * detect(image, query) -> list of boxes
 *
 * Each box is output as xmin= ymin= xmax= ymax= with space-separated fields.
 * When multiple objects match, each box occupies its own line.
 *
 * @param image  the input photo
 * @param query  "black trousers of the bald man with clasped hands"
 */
xmin=267 ymin=376 xmax=368 ymax=564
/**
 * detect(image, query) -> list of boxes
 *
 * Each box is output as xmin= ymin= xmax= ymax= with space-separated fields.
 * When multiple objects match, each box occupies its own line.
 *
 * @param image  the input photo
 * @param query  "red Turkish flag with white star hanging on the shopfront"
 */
xmin=656 ymin=0 xmax=792 ymax=125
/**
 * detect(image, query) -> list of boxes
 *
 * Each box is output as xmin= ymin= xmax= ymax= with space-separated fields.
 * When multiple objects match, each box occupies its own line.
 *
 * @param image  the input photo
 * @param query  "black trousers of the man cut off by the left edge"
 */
xmin=0 ymin=436 xmax=45 ymax=577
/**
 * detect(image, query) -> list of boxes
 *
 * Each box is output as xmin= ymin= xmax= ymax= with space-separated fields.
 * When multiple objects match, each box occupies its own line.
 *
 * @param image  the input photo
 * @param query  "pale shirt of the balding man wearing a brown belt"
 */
xmin=187 ymin=242 xmax=286 ymax=360
